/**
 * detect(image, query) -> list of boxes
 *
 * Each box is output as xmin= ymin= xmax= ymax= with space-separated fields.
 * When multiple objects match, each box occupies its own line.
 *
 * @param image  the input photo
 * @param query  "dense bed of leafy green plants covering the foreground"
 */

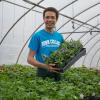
xmin=0 ymin=65 xmax=100 ymax=100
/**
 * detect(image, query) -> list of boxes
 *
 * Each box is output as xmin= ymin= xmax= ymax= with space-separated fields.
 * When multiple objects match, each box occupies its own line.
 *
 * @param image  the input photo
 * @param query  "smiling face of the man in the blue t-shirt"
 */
xmin=43 ymin=11 xmax=57 ymax=29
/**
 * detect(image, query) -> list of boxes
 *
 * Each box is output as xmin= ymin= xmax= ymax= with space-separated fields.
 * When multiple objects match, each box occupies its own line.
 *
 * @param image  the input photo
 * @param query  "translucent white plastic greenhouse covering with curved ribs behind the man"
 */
xmin=0 ymin=0 xmax=100 ymax=67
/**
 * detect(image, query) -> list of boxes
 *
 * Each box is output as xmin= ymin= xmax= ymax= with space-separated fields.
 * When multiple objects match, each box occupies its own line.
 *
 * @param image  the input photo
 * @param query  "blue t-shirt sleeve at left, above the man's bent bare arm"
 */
xmin=28 ymin=34 xmax=39 ymax=51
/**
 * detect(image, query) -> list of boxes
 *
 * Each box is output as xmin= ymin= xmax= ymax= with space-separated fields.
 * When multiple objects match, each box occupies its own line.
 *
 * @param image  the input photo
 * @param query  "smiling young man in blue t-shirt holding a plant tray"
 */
xmin=27 ymin=7 xmax=64 ymax=77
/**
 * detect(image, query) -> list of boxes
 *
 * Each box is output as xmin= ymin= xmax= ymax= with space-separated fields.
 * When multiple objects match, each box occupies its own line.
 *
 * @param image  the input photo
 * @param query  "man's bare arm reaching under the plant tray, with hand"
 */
xmin=27 ymin=49 xmax=59 ymax=72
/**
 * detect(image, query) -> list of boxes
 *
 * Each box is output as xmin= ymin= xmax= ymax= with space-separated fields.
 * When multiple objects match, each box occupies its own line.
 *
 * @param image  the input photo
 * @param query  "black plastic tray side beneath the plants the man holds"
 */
xmin=60 ymin=48 xmax=86 ymax=72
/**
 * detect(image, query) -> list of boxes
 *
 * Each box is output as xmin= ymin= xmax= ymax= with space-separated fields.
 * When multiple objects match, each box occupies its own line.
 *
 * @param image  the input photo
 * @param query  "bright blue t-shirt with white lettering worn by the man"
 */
xmin=29 ymin=29 xmax=64 ymax=63
